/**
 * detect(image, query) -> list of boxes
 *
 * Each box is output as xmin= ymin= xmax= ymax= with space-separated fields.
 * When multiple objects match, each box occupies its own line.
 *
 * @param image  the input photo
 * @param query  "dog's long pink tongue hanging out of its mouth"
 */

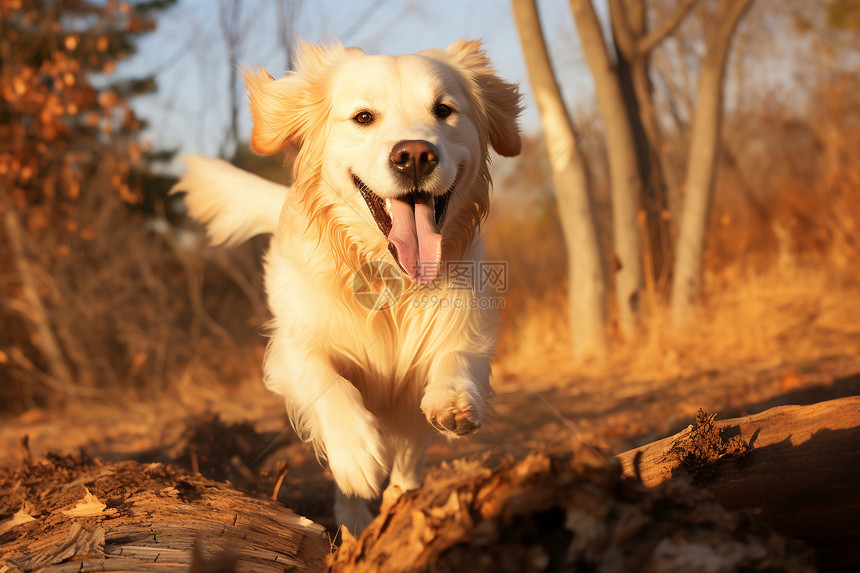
xmin=388 ymin=195 xmax=442 ymax=283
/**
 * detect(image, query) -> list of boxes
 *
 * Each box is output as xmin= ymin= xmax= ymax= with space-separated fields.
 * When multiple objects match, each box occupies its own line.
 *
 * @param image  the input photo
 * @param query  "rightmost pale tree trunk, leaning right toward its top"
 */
xmin=671 ymin=0 xmax=752 ymax=325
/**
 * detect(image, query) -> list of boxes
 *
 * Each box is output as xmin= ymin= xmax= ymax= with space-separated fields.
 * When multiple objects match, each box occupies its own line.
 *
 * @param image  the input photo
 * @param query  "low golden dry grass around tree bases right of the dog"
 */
xmin=490 ymin=249 xmax=860 ymax=386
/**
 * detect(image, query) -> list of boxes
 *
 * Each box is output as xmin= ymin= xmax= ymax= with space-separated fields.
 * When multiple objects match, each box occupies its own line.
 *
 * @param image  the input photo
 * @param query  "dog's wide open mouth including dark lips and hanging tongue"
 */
xmin=352 ymin=167 xmax=463 ymax=284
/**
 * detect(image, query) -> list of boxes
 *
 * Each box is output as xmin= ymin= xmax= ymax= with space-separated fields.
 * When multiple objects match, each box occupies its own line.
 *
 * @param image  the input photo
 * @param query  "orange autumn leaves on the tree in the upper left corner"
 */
xmin=0 ymin=0 xmax=160 ymax=211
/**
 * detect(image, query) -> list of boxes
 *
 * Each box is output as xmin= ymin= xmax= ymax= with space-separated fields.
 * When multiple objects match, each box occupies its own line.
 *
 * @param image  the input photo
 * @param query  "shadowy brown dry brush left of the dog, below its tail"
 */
xmin=0 ymin=183 xmax=267 ymax=412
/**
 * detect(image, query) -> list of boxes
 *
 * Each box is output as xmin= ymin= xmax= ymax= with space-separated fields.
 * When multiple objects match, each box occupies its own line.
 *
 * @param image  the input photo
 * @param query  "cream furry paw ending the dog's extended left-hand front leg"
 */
xmin=325 ymin=412 xmax=389 ymax=499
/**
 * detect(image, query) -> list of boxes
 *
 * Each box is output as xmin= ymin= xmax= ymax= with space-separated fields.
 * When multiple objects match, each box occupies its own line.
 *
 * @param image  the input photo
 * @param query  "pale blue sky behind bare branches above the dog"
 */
xmin=119 ymin=0 xmax=593 ymax=166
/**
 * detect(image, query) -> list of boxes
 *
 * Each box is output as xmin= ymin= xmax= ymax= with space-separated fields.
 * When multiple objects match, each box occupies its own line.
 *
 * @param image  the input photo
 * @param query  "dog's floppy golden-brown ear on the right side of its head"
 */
xmin=445 ymin=40 xmax=523 ymax=157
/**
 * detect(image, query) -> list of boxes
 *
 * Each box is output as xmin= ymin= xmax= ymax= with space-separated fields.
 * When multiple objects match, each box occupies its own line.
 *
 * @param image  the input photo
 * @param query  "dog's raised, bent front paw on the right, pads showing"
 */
xmin=421 ymin=352 xmax=490 ymax=438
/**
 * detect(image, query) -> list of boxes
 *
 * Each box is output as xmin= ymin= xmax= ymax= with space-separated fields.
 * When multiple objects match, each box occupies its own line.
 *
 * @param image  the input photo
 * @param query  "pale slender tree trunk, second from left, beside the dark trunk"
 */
xmin=570 ymin=0 xmax=642 ymax=336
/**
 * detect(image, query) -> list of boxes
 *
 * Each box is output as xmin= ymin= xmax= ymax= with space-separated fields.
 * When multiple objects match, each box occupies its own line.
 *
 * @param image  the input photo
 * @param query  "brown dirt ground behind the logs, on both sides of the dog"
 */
xmin=0 ymin=356 xmax=860 ymax=532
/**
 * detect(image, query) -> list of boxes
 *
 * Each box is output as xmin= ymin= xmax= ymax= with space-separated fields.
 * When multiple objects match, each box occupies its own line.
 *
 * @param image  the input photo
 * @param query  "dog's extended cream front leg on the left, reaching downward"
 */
xmin=265 ymin=333 xmax=390 ymax=512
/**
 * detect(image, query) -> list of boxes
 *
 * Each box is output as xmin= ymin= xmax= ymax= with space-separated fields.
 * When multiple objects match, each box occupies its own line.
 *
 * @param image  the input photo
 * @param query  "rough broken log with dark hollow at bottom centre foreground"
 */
xmin=328 ymin=450 xmax=814 ymax=573
